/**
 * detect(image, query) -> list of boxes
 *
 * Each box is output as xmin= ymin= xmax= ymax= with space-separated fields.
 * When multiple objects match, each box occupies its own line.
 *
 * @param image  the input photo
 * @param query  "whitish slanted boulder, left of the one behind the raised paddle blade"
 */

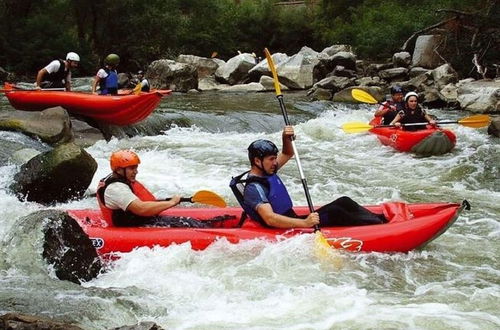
xmin=215 ymin=53 xmax=255 ymax=85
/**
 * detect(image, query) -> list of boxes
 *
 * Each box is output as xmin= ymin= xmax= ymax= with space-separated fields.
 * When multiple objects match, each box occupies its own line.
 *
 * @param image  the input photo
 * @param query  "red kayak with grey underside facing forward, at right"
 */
xmin=370 ymin=117 xmax=457 ymax=156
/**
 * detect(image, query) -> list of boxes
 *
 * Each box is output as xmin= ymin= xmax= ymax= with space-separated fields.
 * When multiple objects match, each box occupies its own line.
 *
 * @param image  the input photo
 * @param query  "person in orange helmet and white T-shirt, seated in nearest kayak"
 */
xmin=96 ymin=150 xmax=206 ymax=228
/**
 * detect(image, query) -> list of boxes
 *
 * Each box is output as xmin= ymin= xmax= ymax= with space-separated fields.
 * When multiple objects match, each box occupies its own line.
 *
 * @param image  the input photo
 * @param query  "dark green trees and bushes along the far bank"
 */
xmin=0 ymin=0 xmax=494 ymax=76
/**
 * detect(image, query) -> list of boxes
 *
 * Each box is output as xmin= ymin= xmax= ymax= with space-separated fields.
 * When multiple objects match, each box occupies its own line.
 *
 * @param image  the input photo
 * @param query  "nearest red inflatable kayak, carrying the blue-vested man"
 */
xmin=68 ymin=201 xmax=470 ymax=255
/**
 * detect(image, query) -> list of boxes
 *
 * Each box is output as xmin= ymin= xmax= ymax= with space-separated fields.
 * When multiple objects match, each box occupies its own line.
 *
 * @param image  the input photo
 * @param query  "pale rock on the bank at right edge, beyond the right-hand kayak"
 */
xmin=457 ymin=80 xmax=500 ymax=113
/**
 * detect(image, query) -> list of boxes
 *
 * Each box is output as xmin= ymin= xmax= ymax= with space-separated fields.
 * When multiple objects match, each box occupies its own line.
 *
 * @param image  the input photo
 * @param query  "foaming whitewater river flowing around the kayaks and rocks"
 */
xmin=0 ymin=93 xmax=500 ymax=329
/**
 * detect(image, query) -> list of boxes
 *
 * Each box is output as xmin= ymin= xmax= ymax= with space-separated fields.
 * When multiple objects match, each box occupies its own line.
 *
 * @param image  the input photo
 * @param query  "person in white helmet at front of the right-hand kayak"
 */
xmin=390 ymin=92 xmax=436 ymax=131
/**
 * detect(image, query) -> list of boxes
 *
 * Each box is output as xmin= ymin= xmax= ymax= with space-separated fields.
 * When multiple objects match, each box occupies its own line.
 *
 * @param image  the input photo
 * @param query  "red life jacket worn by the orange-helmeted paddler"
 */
xmin=96 ymin=174 xmax=156 ymax=227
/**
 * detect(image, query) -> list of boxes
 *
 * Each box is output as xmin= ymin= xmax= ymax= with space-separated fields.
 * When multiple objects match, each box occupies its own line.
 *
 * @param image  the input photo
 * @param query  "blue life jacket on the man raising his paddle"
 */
xmin=229 ymin=171 xmax=296 ymax=227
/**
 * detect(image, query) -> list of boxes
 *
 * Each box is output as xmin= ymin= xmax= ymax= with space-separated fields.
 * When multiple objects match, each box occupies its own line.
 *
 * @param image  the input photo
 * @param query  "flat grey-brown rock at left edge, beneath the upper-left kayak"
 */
xmin=0 ymin=107 xmax=73 ymax=144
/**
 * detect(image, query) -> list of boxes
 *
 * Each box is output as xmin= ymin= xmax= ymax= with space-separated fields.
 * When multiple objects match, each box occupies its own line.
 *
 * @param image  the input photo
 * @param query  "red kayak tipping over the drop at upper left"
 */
xmin=4 ymin=83 xmax=164 ymax=125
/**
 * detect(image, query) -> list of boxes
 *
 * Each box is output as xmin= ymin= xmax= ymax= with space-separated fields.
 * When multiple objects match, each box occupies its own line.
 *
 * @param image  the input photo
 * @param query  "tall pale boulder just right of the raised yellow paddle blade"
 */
xmin=276 ymin=46 xmax=318 ymax=89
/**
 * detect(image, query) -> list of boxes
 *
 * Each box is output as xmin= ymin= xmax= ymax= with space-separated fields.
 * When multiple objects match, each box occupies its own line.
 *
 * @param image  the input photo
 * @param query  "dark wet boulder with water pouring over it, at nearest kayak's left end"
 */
xmin=5 ymin=209 xmax=102 ymax=284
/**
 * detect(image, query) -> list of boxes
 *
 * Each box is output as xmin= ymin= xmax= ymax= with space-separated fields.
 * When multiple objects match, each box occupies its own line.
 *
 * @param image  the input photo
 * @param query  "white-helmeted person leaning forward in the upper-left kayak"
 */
xmin=35 ymin=52 xmax=80 ymax=92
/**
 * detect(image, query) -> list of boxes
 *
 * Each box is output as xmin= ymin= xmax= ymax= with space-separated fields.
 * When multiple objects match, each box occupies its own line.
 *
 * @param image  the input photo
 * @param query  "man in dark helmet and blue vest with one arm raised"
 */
xmin=230 ymin=126 xmax=386 ymax=228
